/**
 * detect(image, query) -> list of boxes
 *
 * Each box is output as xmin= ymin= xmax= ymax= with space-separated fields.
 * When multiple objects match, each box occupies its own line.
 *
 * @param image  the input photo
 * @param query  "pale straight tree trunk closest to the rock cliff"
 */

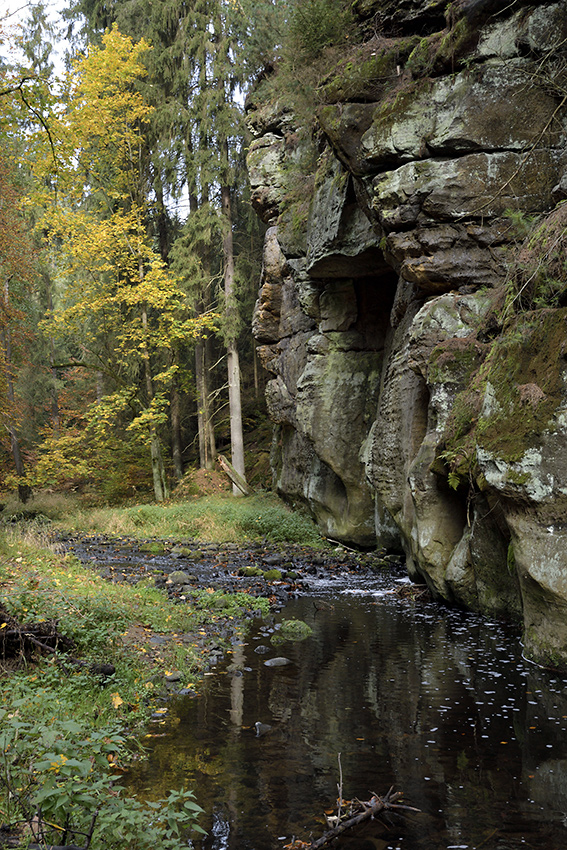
xmin=221 ymin=182 xmax=246 ymax=496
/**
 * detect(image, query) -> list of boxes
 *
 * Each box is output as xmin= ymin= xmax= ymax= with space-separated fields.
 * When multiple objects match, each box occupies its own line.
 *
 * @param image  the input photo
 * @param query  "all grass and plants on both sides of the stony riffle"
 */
xmin=0 ymin=486 xmax=323 ymax=850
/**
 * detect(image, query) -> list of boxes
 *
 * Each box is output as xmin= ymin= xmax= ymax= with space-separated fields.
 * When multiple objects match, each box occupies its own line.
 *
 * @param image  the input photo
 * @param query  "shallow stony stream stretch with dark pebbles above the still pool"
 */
xmin=61 ymin=535 xmax=398 ymax=693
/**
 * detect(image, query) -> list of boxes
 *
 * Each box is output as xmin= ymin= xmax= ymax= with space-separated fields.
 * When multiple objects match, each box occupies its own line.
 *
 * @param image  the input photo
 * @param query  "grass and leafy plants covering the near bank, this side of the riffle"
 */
xmin=0 ymin=520 xmax=268 ymax=850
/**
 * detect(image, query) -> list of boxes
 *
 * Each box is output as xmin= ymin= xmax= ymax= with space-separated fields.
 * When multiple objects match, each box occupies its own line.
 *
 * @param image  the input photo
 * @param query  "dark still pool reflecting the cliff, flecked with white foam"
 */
xmin=127 ymin=580 xmax=567 ymax=850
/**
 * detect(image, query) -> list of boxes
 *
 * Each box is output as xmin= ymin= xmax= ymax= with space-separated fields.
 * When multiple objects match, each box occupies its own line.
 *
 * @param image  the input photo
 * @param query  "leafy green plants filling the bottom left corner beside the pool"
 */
xmin=0 ymin=664 xmax=203 ymax=850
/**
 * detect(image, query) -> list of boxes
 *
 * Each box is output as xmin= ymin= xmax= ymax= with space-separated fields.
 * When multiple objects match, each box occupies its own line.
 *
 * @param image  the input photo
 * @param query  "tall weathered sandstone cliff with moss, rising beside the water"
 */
xmin=249 ymin=0 xmax=567 ymax=663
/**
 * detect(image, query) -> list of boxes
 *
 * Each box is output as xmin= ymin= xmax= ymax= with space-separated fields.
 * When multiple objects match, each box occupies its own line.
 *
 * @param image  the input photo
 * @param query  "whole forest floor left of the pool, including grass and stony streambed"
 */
xmin=0 ymin=480 xmax=400 ymax=850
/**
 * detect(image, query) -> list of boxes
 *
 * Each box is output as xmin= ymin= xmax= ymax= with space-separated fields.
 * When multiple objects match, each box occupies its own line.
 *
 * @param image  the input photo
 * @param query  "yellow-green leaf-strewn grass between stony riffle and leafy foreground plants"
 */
xmin=0 ymin=530 xmax=267 ymax=723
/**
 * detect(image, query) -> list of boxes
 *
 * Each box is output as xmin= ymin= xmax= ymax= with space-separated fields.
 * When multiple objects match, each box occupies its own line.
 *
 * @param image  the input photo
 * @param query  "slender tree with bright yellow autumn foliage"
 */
xmin=33 ymin=28 xmax=215 ymax=501
